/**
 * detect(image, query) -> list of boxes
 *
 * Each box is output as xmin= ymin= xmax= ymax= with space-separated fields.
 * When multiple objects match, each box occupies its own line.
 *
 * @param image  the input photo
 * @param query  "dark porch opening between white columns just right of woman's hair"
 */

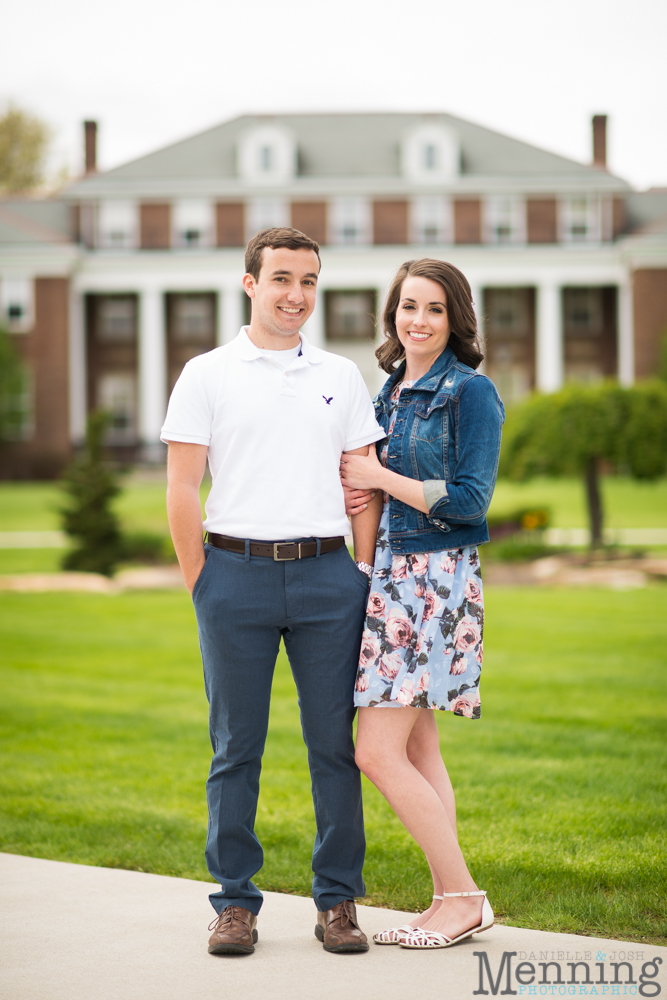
xmin=484 ymin=288 xmax=535 ymax=404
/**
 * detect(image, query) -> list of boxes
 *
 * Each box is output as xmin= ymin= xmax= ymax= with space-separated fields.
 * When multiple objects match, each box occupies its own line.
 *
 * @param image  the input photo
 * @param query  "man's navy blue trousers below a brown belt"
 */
xmin=192 ymin=545 xmax=367 ymax=914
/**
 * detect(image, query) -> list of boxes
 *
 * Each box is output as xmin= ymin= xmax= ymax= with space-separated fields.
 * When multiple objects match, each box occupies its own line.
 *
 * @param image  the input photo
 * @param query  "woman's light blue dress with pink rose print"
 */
xmin=354 ymin=382 xmax=484 ymax=719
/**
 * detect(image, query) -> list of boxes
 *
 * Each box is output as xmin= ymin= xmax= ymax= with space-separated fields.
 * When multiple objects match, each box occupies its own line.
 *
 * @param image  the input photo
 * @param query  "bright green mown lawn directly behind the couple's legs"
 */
xmin=0 ymin=587 xmax=667 ymax=943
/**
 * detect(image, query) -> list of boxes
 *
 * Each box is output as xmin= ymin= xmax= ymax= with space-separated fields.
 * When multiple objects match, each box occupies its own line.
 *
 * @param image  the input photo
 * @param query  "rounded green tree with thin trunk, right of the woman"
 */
xmin=499 ymin=380 xmax=667 ymax=547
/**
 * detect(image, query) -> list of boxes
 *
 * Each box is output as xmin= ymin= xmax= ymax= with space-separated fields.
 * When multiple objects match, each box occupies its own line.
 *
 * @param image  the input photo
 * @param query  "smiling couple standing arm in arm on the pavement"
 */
xmin=162 ymin=229 xmax=503 ymax=954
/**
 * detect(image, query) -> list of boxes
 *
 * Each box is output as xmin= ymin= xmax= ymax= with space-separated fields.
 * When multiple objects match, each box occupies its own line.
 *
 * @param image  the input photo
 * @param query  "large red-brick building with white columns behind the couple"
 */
xmin=0 ymin=114 xmax=667 ymax=476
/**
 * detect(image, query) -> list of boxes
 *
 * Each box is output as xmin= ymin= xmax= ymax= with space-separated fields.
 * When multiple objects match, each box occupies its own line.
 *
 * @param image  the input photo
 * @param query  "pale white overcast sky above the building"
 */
xmin=5 ymin=0 xmax=667 ymax=190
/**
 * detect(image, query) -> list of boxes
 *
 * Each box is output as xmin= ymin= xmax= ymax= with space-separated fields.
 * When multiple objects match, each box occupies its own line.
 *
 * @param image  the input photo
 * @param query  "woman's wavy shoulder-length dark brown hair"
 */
xmin=375 ymin=257 xmax=484 ymax=374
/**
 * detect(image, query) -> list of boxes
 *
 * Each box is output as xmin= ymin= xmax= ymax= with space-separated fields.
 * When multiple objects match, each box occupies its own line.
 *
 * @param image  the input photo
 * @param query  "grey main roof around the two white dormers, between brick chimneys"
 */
xmin=64 ymin=113 xmax=628 ymax=197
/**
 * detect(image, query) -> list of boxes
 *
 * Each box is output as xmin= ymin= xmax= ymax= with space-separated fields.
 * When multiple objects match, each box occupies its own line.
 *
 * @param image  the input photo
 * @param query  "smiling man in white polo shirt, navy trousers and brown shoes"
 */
xmin=161 ymin=229 xmax=384 ymax=954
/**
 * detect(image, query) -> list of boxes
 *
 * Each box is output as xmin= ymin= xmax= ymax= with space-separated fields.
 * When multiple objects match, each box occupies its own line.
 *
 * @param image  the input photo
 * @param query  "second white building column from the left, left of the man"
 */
xmin=138 ymin=288 xmax=167 ymax=461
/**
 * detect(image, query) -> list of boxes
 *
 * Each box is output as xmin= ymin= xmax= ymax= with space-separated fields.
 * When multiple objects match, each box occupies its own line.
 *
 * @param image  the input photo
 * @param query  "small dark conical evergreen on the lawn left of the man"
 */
xmin=61 ymin=412 xmax=122 ymax=576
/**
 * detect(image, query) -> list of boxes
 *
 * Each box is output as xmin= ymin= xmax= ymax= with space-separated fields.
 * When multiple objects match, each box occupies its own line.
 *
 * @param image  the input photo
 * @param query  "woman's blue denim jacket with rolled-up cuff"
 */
xmin=374 ymin=347 xmax=505 ymax=554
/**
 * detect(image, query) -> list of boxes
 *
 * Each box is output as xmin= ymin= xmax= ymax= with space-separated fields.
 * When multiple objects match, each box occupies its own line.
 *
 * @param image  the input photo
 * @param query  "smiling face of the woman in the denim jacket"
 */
xmin=395 ymin=277 xmax=450 ymax=371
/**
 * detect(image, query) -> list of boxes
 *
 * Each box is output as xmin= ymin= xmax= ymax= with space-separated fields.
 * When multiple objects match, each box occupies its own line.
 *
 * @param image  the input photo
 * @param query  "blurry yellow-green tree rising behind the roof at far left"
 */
xmin=0 ymin=107 xmax=51 ymax=192
